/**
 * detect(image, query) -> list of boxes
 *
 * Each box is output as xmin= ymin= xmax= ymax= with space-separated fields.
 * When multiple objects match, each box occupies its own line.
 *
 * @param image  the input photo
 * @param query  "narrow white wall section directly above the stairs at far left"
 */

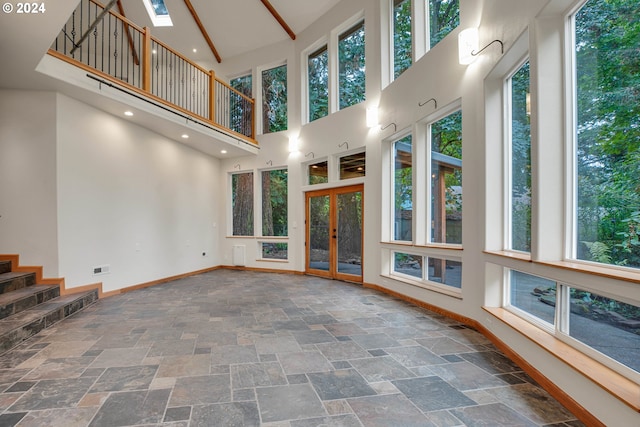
xmin=0 ymin=90 xmax=59 ymax=277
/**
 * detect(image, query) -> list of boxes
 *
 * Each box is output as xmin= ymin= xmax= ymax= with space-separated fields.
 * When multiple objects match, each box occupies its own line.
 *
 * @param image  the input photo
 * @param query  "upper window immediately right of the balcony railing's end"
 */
xmin=262 ymin=64 xmax=287 ymax=133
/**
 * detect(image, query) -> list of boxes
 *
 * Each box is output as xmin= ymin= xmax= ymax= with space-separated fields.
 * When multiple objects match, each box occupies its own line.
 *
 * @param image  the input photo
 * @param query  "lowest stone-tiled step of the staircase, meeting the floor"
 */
xmin=0 ymin=290 xmax=98 ymax=354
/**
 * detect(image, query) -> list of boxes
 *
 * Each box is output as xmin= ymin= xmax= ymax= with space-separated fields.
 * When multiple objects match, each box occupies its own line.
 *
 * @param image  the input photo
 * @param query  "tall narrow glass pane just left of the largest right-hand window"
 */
xmin=509 ymin=61 xmax=531 ymax=252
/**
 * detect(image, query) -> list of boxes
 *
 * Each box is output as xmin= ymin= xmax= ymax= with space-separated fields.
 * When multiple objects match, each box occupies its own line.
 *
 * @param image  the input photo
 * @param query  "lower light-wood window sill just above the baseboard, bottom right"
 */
xmin=483 ymin=307 xmax=640 ymax=412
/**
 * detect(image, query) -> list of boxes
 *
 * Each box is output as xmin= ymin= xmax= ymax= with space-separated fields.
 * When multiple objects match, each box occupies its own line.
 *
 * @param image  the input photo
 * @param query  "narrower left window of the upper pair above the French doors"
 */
xmin=307 ymin=45 xmax=329 ymax=122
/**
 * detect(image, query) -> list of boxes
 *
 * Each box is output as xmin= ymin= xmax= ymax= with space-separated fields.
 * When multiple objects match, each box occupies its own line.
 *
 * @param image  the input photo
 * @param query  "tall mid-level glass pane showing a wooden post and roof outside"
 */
xmin=431 ymin=111 xmax=462 ymax=243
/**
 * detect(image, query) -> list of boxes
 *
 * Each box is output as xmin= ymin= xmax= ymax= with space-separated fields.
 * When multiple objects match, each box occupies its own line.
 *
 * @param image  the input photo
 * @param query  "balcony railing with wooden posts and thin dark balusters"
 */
xmin=49 ymin=0 xmax=257 ymax=144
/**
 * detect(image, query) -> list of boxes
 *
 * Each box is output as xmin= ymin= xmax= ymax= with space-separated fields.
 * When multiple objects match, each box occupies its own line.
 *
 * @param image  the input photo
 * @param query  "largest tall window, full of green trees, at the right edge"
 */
xmin=574 ymin=0 xmax=640 ymax=268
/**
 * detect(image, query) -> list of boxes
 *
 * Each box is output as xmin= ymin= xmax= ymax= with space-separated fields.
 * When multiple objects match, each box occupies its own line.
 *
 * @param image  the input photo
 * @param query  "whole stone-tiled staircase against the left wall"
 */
xmin=0 ymin=260 xmax=98 ymax=354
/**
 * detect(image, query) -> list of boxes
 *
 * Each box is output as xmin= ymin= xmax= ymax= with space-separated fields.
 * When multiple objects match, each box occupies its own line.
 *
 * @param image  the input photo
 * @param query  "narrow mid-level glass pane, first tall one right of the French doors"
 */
xmin=393 ymin=135 xmax=413 ymax=242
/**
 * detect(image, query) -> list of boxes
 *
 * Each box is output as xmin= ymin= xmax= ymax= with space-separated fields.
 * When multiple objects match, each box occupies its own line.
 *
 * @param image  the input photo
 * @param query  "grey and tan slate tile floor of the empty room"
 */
xmin=0 ymin=270 xmax=583 ymax=427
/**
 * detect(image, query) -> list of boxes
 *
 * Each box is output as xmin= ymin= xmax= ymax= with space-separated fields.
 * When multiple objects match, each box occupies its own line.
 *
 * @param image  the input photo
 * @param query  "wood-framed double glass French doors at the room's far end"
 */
xmin=305 ymin=185 xmax=364 ymax=283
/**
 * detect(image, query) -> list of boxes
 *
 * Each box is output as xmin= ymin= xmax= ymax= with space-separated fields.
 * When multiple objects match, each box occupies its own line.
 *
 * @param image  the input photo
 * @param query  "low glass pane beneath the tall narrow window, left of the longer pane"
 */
xmin=509 ymin=270 xmax=556 ymax=325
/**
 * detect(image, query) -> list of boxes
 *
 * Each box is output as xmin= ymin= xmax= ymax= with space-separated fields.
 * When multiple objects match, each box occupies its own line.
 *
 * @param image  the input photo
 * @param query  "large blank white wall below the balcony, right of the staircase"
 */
xmin=57 ymin=95 xmax=223 ymax=291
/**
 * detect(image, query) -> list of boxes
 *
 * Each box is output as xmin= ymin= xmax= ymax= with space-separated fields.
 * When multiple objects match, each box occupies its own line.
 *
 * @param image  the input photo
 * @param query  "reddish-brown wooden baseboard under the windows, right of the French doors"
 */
xmin=363 ymin=283 xmax=606 ymax=427
